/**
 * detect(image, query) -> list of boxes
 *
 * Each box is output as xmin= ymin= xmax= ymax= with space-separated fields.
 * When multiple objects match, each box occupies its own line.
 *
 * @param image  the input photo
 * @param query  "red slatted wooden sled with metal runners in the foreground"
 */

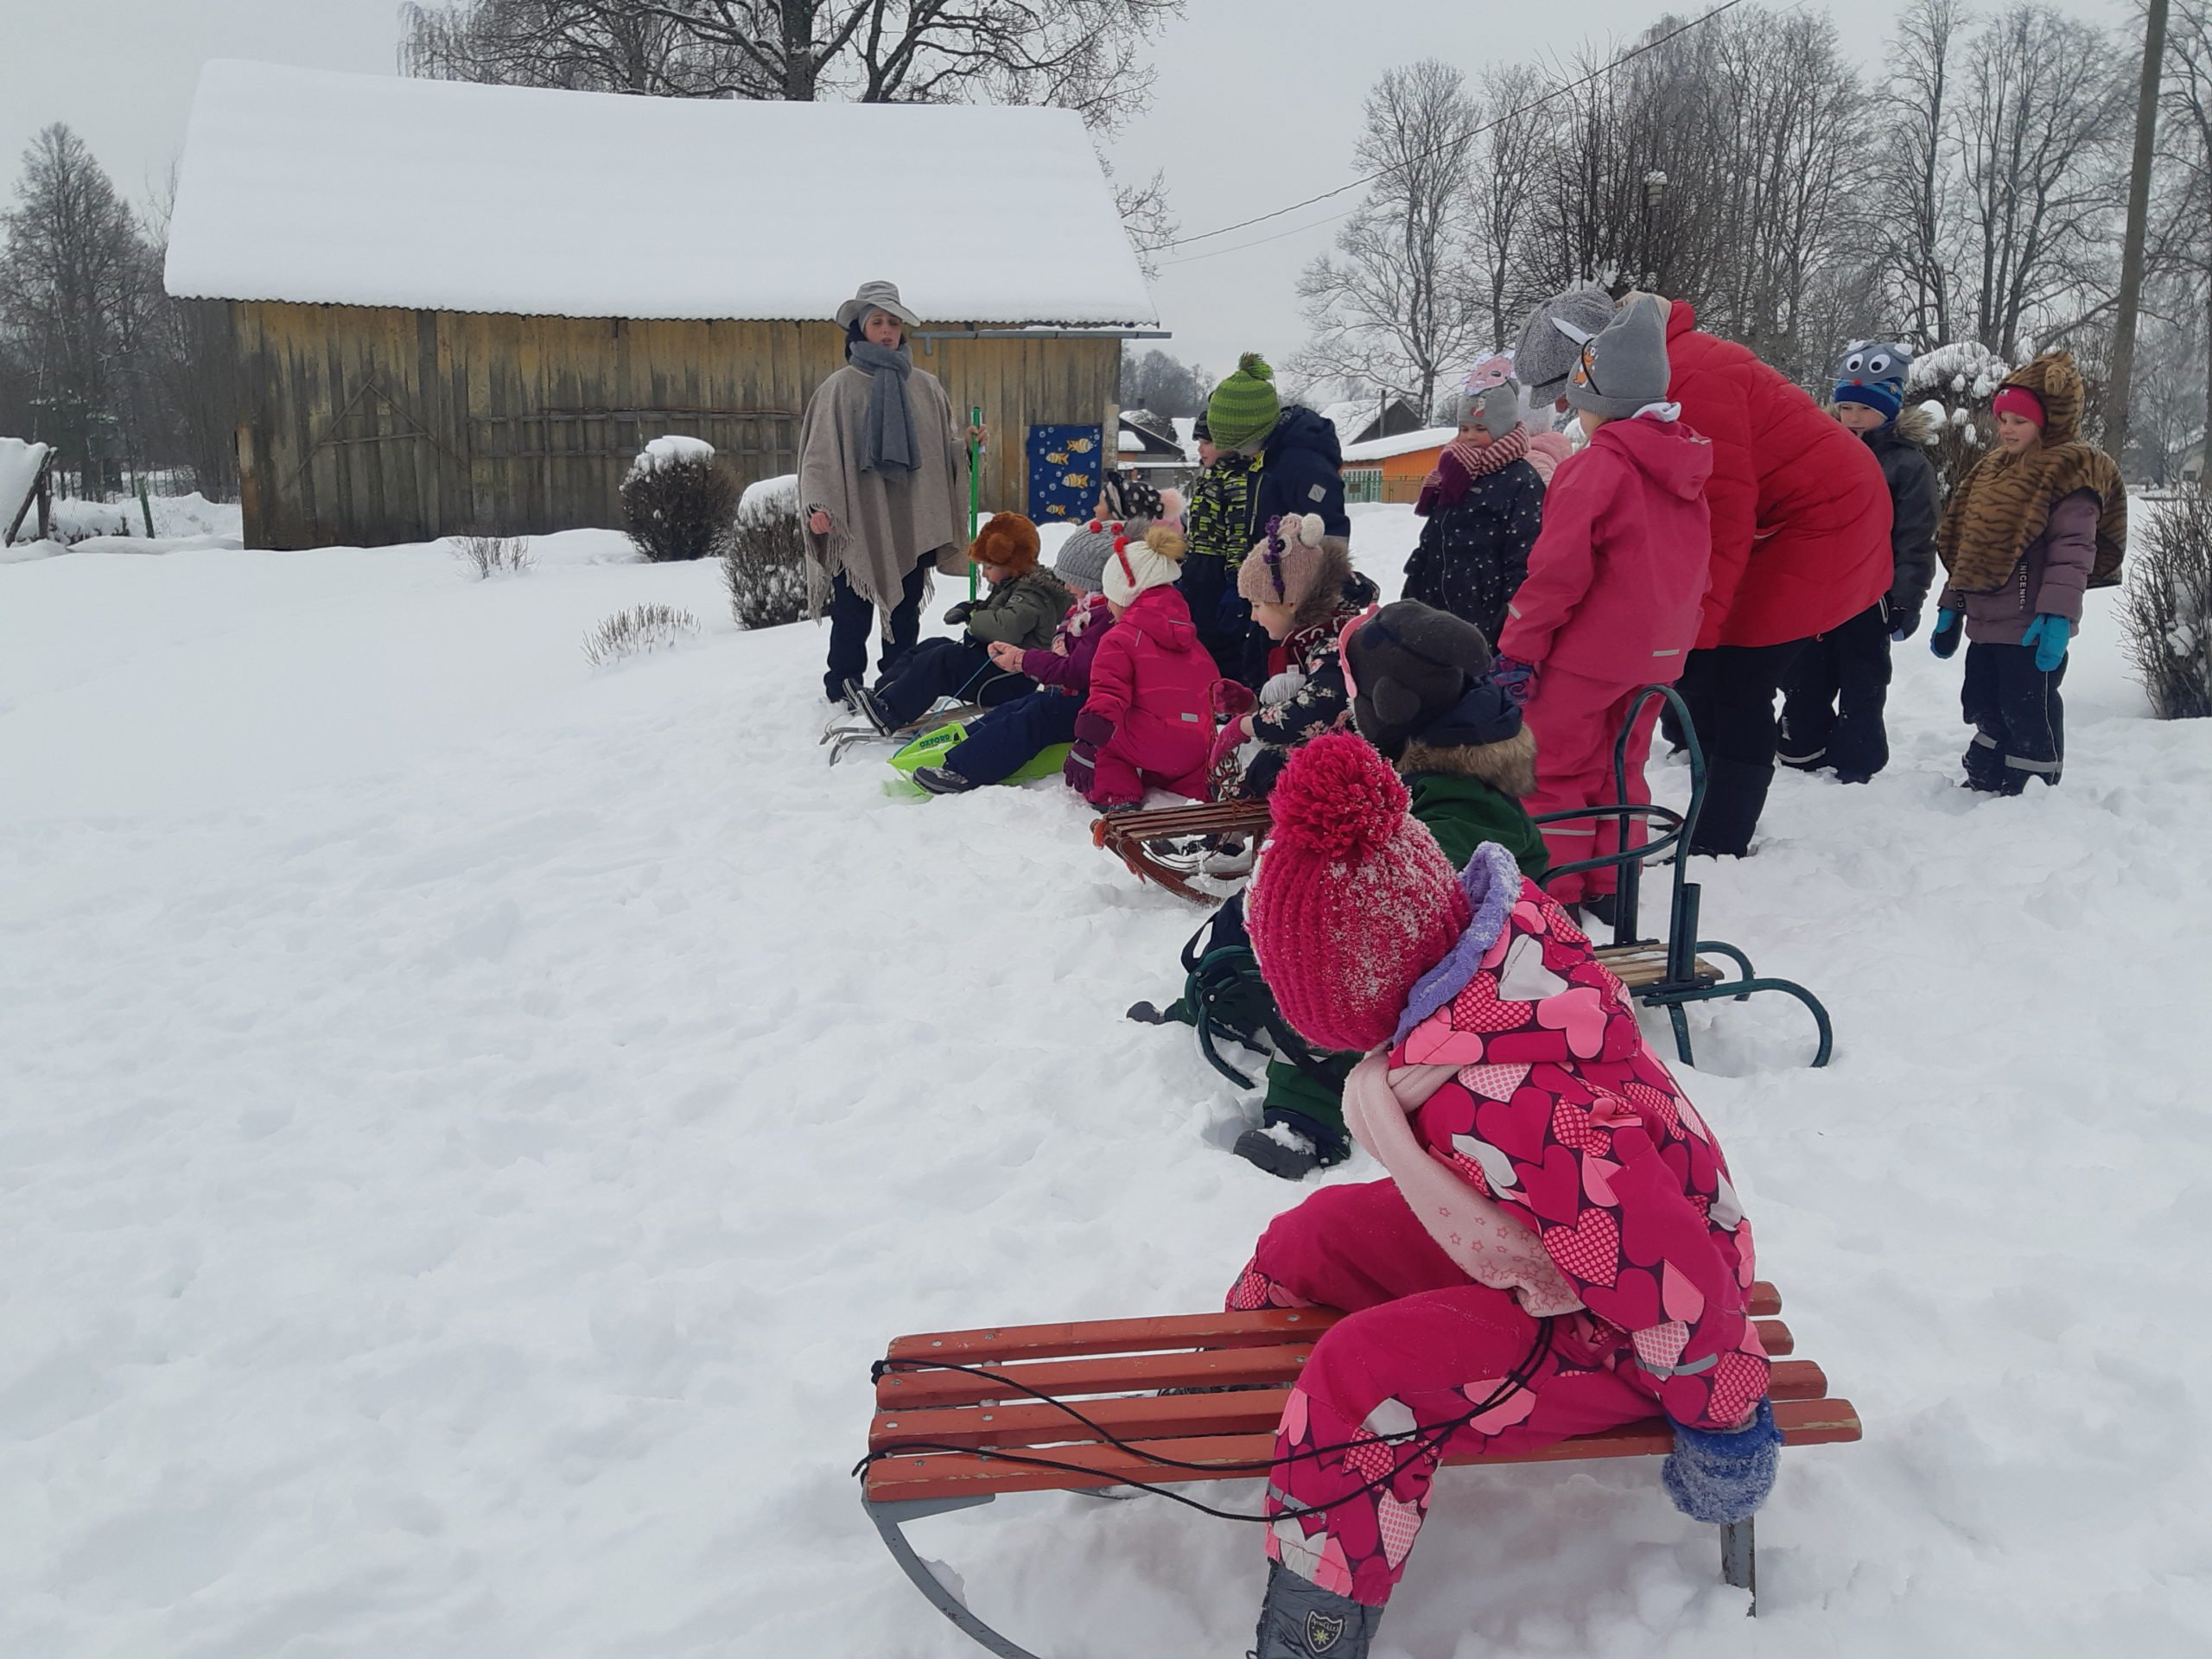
xmin=856 ymin=1283 xmax=1860 ymax=1659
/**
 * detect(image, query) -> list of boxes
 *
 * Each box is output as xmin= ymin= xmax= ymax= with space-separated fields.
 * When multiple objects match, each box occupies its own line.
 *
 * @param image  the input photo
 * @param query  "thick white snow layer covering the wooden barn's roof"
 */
xmin=168 ymin=60 xmax=1157 ymax=325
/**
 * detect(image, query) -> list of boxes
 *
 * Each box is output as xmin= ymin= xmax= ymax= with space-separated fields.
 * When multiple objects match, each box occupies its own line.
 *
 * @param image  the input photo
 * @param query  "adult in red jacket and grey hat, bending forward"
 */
xmin=1516 ymin=288 xmax=1891 ymax=856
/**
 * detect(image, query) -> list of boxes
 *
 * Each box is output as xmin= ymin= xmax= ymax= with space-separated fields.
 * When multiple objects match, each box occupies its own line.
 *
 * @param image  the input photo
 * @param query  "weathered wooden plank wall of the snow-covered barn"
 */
xmin=232 ymin=301 xmax=1122 ymax=549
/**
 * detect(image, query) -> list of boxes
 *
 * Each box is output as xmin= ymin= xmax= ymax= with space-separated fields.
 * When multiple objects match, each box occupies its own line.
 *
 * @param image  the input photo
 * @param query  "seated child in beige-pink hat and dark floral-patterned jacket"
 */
xmin=1212 ymin=513 xmax=1378 ymax=801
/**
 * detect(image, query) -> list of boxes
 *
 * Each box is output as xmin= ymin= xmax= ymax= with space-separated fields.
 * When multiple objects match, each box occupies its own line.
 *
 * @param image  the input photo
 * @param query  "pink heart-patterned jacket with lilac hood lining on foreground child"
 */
xmin=1389 ymin=847 xmax=1767 ymax=1429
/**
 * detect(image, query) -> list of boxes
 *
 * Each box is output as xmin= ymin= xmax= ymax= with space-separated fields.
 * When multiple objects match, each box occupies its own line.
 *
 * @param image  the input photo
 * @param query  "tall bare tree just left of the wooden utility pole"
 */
xmin=1951 ymin=4 xmax=2126 ymax=356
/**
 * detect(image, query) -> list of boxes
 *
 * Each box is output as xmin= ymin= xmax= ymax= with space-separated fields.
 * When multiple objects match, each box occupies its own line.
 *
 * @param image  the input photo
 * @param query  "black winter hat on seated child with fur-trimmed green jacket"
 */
xmin=1344 ymin=600 xmax=1520 ymax=759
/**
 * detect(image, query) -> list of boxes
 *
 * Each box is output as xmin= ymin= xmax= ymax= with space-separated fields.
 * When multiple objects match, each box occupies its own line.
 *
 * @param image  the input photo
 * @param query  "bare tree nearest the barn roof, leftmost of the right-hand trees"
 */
xmin=1294 ymin=58 xmax=1484 ymax=410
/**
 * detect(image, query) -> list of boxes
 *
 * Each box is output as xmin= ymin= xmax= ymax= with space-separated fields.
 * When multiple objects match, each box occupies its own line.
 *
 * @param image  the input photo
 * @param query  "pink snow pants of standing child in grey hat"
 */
xmin=1522 ymin=668 xmax=1659 ymax=905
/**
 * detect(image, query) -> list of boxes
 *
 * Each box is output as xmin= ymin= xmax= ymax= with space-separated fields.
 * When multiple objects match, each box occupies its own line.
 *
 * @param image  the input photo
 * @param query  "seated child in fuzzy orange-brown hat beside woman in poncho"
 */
xmin=845 ymin=513 xmax=1075 ymax=734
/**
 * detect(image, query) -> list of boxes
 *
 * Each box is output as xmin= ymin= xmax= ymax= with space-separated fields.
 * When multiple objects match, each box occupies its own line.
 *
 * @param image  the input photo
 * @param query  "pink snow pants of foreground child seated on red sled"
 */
xmin=1228 ymin=1181 xmax=1659 ymax=1606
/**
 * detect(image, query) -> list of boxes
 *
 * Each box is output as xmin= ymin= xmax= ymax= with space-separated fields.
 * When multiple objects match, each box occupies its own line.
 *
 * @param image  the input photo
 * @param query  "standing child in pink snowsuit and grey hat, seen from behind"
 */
xmin=1497 ymin=299 xmax=1712 ymax=920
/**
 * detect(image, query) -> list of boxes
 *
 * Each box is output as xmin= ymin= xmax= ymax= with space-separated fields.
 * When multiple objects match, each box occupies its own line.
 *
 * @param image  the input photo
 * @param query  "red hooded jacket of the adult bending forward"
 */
xmin=1663 ymin=299 xmax=1891 ymax=651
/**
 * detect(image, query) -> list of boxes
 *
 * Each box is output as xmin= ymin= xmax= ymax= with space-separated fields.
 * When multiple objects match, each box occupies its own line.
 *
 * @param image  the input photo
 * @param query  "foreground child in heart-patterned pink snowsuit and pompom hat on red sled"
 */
xmin=1228 ymin=734 xmax=1781 ymax=1659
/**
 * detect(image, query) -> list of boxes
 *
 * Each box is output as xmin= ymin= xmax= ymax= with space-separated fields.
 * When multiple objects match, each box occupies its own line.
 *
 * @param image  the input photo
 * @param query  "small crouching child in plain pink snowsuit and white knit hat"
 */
xmin=1066 ymin=524 xmax=1219 ymax=812
